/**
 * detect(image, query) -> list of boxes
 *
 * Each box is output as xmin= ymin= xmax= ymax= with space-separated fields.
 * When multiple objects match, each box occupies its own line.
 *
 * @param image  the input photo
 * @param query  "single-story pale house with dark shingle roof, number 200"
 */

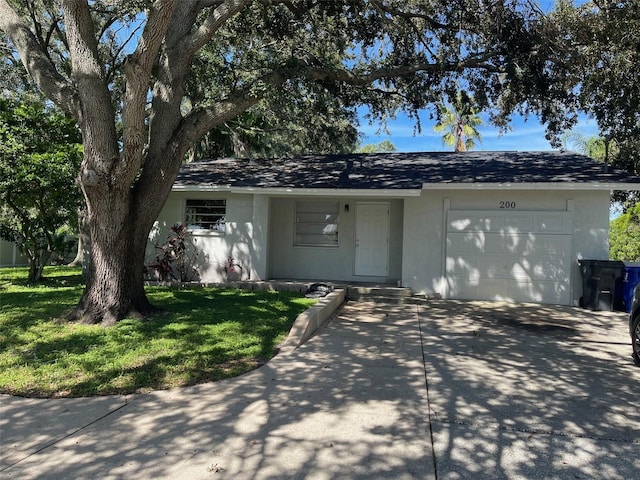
xmin=154 ymin=151 xmax=640 ymax=305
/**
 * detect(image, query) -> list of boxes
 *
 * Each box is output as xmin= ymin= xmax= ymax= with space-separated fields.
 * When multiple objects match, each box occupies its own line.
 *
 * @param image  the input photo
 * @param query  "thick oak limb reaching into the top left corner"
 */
xmin=0 ymin=0 xmax=82 ymax=121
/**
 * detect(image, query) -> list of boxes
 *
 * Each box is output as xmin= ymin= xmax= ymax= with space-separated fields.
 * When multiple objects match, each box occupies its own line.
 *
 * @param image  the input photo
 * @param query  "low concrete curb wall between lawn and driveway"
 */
xmin=280 ymin=289 xmax=347 ymax=354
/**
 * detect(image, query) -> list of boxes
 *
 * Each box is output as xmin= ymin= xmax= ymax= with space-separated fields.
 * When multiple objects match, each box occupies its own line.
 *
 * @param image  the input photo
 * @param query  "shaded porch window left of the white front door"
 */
xmin=294 ymin=202 xmax=340 ymax=247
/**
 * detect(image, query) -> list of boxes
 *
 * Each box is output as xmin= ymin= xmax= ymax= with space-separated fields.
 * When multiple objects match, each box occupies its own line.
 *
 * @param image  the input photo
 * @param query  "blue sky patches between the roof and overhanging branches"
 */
xmin=359 ymin=109 xmax=598 ymax=152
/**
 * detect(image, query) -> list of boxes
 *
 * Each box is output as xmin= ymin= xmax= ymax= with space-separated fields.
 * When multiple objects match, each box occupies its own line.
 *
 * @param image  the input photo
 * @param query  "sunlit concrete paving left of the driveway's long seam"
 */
xmin=0 ymin=303 xmax=435 ymax=480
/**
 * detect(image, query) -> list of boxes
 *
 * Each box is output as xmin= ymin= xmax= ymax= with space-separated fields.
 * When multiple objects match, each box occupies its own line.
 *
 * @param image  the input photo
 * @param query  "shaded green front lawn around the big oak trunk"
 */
xmin=0 ymin=267 xmax=313 ymax=398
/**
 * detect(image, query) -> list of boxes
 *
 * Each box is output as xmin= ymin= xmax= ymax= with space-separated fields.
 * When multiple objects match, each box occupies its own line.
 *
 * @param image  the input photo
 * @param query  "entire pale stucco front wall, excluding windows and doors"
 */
xmin=158 ymin=190 xmax=609 ymax=303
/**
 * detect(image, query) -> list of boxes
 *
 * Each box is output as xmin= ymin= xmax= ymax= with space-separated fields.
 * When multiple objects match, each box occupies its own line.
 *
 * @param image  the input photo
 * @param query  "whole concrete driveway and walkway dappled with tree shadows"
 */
xmin=0 ymin=301 xmax=640 ymax=479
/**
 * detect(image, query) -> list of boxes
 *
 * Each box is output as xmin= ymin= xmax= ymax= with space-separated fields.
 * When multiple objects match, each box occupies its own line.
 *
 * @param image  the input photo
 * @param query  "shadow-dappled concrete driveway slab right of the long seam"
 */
xmin=421 ymin=301 xmax=640 ymax=479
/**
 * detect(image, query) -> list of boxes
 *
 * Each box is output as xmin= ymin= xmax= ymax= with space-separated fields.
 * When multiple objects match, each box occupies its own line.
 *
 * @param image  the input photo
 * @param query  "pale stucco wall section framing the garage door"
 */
xmin=402 ymin=190 xmax=609 ymax=303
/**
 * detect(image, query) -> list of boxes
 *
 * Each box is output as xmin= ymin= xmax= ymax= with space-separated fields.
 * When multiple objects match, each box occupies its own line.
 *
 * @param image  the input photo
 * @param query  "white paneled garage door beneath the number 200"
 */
xmin=445 ymin=210 xmax=572 ymax=305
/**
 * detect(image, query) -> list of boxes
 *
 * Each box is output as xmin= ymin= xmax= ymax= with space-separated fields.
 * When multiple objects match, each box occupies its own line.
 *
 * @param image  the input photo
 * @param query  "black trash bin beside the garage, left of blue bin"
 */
xmin=578 ymin=260 xmax=624 ymax=311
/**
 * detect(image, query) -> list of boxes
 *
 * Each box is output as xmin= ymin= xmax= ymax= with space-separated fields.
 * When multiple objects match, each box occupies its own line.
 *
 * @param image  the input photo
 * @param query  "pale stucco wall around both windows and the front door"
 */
xmin=156 ymin=192 xmax=404 ymax=283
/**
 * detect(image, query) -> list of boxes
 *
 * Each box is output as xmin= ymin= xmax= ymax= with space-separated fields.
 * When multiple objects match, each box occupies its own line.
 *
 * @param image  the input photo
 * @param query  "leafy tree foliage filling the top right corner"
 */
xmin=550 ymin=0 xmax=640 ymax=208
